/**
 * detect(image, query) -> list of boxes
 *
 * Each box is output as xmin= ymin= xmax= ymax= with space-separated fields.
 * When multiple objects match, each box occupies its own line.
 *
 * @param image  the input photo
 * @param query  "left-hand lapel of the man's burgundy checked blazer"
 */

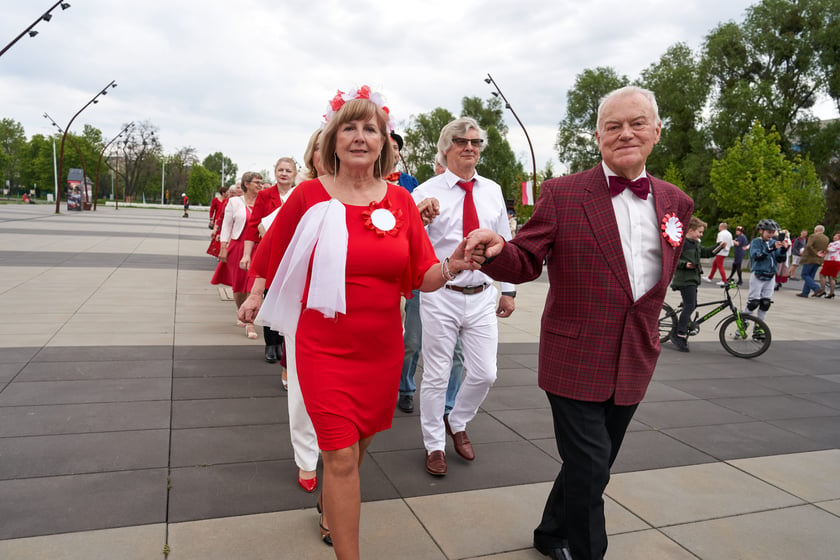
xmin=580 ymin=164 xmax=633 ymax=300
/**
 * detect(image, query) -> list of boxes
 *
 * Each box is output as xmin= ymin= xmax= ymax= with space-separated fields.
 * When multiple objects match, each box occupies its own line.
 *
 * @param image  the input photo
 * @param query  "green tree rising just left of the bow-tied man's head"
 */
xmin=554 ymin=67 xmax=629 ymax=173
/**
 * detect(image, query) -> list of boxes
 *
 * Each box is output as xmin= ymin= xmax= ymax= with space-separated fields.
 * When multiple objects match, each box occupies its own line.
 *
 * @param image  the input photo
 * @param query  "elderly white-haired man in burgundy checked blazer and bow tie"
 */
xmin=467 ymin=86 xmax=694 ymax=560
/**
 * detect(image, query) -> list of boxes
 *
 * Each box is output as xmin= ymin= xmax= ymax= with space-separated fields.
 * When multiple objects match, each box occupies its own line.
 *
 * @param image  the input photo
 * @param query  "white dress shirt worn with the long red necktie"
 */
xmin=411 ymin=169 xmax=516 ymax=292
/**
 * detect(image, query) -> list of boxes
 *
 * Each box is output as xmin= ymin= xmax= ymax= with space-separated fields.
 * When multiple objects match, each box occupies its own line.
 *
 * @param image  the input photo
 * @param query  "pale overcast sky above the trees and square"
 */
xmin=0 ymin=0 xmax=834 ymax=179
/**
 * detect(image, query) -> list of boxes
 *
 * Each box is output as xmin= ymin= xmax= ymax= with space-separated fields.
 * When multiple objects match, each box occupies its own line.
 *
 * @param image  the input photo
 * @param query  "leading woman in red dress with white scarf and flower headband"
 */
xmin=240 ymin=86 xmax=474 ymax=560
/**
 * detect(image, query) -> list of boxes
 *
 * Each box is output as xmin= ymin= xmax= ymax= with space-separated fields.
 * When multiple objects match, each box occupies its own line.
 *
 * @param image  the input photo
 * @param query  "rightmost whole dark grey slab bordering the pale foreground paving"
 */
xmin=664 ymin=422 xmax=828 ymax=459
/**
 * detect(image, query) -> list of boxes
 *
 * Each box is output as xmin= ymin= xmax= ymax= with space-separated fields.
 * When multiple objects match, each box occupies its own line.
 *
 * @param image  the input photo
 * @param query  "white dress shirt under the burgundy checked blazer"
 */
xmin=601 ymin=161 xmax=662 ymax=301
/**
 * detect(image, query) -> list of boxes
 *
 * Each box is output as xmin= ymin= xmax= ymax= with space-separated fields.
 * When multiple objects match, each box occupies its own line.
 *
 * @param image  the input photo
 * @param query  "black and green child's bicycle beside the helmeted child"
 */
xmin=659 ymin=280 xmax=772 ymax=359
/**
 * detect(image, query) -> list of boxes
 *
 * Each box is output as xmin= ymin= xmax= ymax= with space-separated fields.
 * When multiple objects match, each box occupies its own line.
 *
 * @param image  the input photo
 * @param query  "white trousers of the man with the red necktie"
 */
xmin=420 ymin=285 xmax=499 ymax=452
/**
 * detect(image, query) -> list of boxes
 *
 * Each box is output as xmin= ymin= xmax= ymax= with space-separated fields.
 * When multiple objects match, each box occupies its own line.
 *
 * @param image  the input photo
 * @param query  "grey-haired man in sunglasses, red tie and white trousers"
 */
xmin=411 ymin=117 xmax=516 ymax=476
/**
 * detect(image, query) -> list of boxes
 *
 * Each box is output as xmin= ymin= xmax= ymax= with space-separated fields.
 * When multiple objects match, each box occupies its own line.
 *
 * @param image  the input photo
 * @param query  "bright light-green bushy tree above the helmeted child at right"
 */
xmin=711 ymin=121 xmax=825 ymax=235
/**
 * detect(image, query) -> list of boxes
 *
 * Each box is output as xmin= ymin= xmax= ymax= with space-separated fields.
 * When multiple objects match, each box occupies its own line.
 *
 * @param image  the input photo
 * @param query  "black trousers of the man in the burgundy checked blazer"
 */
xmin=534 ymin=393 xmax=638 ymax=560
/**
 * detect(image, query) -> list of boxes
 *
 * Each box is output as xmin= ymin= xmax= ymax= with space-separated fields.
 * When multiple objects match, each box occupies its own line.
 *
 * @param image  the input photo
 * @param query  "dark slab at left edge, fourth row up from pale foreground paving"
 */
xmin=0 ymin=378 xmax=172 ymax=406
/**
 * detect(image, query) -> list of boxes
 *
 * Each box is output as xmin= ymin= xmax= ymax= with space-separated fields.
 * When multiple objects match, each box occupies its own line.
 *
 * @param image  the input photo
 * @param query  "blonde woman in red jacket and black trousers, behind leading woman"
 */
xmin=239 ymin=157 xmax=297 ymax=368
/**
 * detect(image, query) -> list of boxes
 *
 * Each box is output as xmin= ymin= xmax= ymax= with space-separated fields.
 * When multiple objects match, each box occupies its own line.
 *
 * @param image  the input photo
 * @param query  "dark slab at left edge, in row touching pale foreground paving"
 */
xmin=0 ymin=469 xmax=167 ymax=539
